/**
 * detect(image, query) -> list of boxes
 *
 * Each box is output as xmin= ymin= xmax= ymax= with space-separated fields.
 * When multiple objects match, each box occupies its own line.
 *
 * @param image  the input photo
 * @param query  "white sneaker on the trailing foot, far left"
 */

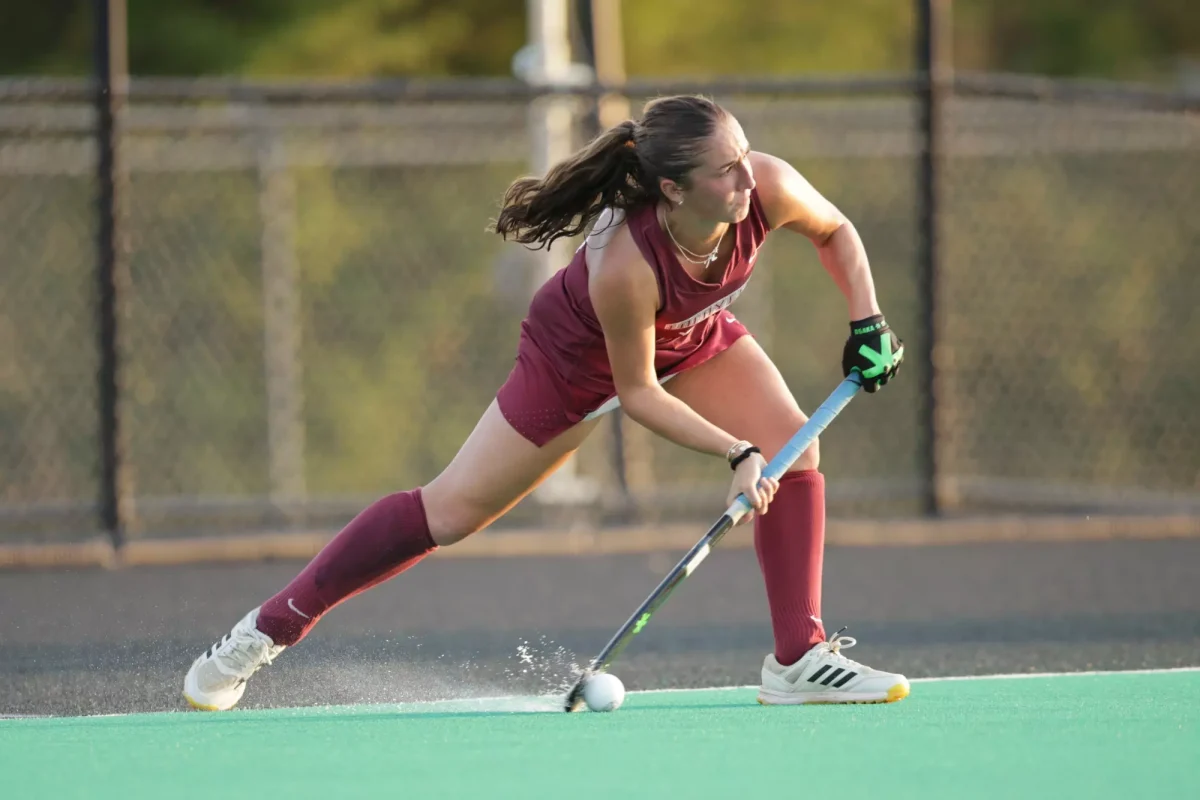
xmin=184 ymin=608 xmax=286 ymax=711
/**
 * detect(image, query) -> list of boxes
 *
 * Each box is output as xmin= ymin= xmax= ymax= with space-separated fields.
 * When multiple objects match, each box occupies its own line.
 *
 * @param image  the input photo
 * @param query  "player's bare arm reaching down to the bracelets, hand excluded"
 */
xmin=588 ymin=229 xmax=738 ymax=456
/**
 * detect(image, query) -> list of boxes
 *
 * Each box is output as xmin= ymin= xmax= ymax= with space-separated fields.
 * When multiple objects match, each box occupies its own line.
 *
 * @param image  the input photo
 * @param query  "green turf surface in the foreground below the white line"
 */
xmin=0 ymin=672 xmax=1200 ymax=800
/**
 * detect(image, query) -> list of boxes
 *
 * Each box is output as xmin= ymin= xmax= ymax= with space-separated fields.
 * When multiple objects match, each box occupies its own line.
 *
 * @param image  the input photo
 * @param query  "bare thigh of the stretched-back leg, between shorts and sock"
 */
xmin=421 ymin=399 xmax=596 ymax=545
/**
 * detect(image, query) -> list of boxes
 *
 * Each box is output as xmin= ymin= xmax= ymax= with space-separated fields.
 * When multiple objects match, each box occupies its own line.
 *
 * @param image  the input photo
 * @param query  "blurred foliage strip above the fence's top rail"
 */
xmin=0 ymin=0 xmax=1200 ymax=83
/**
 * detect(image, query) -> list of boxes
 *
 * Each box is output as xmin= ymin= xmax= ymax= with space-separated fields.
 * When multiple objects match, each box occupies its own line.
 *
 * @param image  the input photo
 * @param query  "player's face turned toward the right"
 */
xmin=684 ymin=116 xmax=755 ymax=222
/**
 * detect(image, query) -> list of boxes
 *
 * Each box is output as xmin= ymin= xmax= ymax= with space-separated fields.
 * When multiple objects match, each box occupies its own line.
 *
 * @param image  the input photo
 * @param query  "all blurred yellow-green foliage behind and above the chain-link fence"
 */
xmin=0 ymin=0 xmax=1200 ymax=540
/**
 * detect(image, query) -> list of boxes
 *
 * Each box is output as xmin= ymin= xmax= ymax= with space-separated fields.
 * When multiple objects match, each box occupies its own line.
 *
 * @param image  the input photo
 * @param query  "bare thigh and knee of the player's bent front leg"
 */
xmin=664 ymin=336 xmax=820 ymax=471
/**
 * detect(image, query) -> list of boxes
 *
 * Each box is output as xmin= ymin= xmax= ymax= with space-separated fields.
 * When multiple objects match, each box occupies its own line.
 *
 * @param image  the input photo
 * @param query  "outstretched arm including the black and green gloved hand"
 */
xmin=750 ymin=152 xmax=904 ymax=392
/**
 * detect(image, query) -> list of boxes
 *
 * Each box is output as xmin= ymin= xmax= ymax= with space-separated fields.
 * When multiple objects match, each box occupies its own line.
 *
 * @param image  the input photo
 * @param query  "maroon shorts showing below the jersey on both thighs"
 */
xmin=496 ymin=311 xmax=749 ymax=447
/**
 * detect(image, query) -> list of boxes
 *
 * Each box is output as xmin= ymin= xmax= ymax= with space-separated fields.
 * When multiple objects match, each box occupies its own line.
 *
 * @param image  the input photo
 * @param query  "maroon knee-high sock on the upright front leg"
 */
xmin=754 ymin=469 xmax=826 ymax=666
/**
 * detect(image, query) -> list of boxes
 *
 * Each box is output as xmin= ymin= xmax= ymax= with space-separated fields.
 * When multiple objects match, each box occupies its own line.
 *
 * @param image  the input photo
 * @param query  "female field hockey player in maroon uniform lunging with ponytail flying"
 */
xmin=184 ymin=96 xmax=908 ymax=710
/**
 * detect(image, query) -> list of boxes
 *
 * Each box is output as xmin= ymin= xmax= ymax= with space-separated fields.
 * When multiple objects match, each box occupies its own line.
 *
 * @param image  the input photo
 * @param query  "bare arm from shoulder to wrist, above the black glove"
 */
xmin=750 ymin=152 xmax=880 ymax=319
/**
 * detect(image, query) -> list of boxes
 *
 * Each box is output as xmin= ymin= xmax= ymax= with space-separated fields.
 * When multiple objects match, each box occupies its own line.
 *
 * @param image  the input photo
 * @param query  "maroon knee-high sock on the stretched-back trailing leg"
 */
xmin=258 ymin=488 xmax=437 ymax=645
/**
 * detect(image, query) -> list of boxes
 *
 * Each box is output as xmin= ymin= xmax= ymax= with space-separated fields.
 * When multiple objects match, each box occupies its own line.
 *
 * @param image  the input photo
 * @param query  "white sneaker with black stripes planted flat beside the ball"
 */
xmin=758 ymin=628 xmax=908 ymax=705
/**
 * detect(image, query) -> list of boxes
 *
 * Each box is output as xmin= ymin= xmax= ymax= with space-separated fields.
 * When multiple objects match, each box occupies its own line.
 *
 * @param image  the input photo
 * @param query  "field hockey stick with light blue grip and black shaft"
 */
xmin=564 ymin=372 xmax=863 ymax=711
